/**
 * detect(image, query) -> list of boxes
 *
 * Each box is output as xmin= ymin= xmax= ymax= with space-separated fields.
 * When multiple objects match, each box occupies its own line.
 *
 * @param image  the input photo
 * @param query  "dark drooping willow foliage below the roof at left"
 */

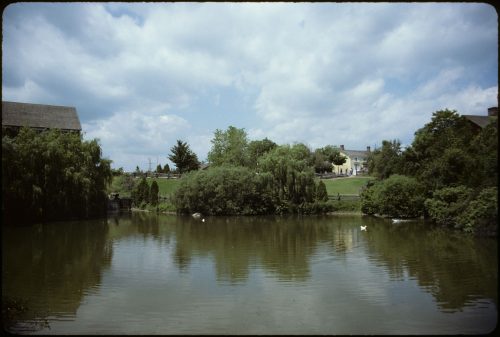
xmin=2 ymin=128 xmax=112 ymax=224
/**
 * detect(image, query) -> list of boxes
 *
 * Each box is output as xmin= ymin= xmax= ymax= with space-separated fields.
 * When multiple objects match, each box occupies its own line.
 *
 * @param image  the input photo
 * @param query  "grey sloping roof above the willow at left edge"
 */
xmin=2 ymin=101 xmax=82 ymax=131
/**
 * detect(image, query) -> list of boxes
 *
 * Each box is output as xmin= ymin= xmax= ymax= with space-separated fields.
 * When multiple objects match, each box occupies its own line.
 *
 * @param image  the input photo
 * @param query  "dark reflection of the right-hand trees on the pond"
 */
xmin=367 ymin=222 xmax=498 ymax=312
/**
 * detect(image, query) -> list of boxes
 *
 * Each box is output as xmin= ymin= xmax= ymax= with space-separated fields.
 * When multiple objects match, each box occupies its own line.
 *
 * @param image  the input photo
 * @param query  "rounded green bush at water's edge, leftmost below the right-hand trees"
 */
xmin=361 ymin=174 xmax=424 ymax=218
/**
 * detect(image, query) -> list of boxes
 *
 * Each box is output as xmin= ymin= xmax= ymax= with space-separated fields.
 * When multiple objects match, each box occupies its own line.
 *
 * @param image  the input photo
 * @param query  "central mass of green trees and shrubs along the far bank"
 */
xmin=110 ymin=126 xmax=370 ymax=215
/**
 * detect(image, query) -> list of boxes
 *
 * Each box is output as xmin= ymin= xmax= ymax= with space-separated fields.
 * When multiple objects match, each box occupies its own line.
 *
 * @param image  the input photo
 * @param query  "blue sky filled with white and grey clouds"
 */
xmin=2 ymin=2 xmax=498 ymax=171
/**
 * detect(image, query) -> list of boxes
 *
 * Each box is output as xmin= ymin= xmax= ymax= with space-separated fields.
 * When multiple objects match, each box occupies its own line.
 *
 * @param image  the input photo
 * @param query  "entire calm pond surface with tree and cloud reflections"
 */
xmin=2 ymin=213 xmax=498 ymax=334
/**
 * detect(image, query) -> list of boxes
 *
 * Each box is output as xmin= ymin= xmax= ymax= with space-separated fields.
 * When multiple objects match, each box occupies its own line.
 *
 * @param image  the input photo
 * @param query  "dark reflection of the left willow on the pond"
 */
xmin=2 ymin=220 xmax=113 ymax=330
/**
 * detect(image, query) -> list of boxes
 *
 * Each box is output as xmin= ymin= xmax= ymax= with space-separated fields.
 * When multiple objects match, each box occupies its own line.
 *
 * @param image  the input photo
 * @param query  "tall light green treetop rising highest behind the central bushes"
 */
xmin=207 ymin=126 xmax=249 ymax=166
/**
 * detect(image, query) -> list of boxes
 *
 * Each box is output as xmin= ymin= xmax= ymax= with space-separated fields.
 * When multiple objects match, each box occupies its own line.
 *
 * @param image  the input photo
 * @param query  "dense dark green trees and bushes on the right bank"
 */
xmin=361 ymin=110 xmax=498 ymax=235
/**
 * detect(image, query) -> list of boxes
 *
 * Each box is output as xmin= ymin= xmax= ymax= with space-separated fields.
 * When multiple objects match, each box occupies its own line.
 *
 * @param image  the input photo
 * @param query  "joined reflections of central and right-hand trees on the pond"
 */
xmin=167 ymin=217 xmax=498 ymax=311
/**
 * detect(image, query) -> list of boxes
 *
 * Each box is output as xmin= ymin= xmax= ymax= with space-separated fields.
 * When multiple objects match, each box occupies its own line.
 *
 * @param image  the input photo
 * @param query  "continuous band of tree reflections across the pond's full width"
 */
xmin=2 ymin=213 xmax=498 ymax=332
